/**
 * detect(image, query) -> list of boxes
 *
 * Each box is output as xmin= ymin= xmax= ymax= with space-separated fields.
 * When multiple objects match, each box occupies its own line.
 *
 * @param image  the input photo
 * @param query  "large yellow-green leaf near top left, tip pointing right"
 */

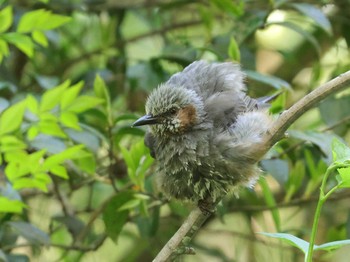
xmin=17 ymin=9 xmax=71 ymax=33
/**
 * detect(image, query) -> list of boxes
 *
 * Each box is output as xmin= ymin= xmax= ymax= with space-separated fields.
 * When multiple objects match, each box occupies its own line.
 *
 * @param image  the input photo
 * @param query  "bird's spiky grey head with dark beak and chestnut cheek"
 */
xmin=133 ymin=84 xmax=204 ymax=137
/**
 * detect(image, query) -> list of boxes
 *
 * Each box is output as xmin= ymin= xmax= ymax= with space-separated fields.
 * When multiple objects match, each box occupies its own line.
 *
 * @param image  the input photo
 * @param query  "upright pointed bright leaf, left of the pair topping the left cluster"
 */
xmin=40 ymin=80 xmax=70 ymax=112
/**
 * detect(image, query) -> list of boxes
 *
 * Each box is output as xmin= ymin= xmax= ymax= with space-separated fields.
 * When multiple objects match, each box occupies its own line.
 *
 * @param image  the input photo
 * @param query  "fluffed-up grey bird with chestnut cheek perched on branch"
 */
xmin=133 ymin=61 xmax=271 ymax=209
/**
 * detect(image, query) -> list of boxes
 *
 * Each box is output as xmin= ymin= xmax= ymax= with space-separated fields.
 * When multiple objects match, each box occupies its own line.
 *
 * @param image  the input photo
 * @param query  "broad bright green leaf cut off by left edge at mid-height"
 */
xmin=0 ymin=101 xmax=26 ymax=136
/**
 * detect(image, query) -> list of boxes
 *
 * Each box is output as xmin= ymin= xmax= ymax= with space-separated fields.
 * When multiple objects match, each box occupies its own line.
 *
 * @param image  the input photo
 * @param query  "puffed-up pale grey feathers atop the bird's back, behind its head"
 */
xmin=167 ymin=61 xmax=245 ymax=100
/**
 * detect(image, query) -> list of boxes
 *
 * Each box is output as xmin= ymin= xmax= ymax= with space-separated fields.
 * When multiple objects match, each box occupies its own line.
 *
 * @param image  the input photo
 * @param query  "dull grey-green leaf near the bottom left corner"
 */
xmin=6 ymin=221 xmax=50 ymax=246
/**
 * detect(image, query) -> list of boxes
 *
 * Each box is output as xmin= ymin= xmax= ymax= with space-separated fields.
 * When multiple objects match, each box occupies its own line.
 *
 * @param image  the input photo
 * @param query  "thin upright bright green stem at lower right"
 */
xmin=305 ymin=165 xmax=338 ymax=262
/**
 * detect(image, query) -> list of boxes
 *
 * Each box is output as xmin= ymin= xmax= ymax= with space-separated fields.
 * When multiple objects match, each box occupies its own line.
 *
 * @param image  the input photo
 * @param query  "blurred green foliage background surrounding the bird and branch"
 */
xmin=0 ymin=0 xmax=350 ymax=262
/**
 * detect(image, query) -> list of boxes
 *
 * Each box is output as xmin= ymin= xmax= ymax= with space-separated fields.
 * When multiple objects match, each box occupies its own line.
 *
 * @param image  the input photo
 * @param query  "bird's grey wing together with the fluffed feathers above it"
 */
xmin=167 ymin=61 xmax=252 ymax=127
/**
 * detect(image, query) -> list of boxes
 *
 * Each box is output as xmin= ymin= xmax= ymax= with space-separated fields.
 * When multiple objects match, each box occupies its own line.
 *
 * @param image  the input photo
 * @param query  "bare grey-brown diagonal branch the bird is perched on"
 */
xmin=153 ymin=71 xmax=350 ymax=262
